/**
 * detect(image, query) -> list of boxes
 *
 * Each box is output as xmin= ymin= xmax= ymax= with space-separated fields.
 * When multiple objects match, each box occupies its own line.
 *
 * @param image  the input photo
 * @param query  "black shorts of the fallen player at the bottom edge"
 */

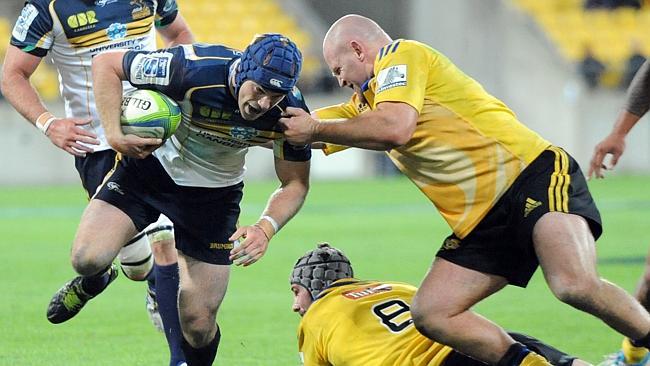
xmin=440 ymin=332 xmax=576 ymax=366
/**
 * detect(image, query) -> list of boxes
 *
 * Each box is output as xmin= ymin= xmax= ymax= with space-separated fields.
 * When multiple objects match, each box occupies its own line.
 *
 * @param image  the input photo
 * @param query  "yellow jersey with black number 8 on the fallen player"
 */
xmin=298 ymin=279 xmax=452 ymax=366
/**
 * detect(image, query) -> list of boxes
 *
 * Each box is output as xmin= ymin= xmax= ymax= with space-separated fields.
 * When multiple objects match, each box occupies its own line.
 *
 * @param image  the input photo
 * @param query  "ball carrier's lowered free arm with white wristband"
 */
xmin=230 ymin=158 xmax=309 ymax=266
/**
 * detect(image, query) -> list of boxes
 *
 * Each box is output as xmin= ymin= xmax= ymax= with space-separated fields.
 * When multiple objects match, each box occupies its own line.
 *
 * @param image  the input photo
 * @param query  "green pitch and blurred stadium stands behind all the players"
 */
xmin=0 ymin=0 xmax=650 ymax=365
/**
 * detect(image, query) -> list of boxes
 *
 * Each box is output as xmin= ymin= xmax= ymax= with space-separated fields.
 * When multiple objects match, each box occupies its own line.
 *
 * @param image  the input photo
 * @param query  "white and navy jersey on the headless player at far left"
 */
xmin=11 ymin=0 xmax=178 ymax=151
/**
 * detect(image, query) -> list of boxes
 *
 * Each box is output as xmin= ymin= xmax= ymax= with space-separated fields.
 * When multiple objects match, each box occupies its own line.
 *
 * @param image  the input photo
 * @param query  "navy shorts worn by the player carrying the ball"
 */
xmin=94 ymin=156 xmax=244 ymax=264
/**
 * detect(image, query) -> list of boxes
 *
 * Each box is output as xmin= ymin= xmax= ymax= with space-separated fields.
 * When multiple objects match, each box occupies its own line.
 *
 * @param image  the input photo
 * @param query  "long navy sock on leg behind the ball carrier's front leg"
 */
xmin=154 ymin=263 xmax=185 ymax=366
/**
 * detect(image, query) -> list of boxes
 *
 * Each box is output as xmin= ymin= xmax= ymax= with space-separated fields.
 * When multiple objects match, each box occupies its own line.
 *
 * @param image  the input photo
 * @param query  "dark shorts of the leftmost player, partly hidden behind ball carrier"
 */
xmin=74 ymin=149 xmax=117 ymax=199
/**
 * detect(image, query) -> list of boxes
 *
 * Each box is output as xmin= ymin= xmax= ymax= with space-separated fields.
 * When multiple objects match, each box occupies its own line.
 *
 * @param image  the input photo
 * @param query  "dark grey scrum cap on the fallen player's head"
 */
xmin=289 ymin=243 xmax=354 ymax=300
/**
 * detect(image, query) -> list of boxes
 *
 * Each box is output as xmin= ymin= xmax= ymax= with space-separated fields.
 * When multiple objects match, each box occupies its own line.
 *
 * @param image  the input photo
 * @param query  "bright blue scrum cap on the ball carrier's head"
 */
xmin=235 ymin=33 xmax=302 ymax=93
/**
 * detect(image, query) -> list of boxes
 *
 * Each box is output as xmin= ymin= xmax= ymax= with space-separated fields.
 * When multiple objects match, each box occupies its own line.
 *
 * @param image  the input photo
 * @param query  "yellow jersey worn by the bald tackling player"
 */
xmin=316 ymin=40 xmax=551 ymax=238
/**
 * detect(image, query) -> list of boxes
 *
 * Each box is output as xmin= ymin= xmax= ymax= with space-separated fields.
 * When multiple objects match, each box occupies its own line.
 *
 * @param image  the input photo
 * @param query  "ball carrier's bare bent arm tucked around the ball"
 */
xmin=92 ymin=51 xmax=162 ymax=159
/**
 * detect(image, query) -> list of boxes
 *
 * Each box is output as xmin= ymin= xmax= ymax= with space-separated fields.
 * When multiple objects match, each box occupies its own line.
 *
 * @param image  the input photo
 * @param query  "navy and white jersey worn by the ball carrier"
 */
xmin=123 ymin=43 xmax=311 ymax=187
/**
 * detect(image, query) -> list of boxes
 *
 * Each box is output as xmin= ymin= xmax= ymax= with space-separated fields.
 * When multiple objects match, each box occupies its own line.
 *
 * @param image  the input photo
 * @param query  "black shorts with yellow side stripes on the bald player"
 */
xmin=437 ymin=147 xmax=602 ymax=287
